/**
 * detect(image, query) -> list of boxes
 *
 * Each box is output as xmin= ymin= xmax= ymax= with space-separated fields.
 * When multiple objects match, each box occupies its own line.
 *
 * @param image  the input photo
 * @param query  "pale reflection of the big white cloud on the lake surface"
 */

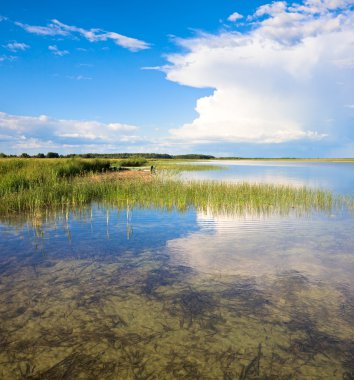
xmin=167 ymin=212 xmax=354 ymax=284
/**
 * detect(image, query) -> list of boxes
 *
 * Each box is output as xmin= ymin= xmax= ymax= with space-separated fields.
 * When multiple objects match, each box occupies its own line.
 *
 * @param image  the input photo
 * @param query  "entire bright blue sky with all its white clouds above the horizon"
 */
xmin=0 ymin=0 xmax=354 ymax=157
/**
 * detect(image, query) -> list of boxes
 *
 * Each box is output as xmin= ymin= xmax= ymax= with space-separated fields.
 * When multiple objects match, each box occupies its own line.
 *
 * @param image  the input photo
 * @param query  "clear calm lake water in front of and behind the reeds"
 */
xmin=0 ymin=162 xmax=354 ymax=379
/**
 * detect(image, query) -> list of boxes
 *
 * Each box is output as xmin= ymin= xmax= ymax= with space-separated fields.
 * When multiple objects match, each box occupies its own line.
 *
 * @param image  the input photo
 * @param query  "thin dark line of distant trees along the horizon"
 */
xmin=0 ymin=152 xmax=215 ymax=160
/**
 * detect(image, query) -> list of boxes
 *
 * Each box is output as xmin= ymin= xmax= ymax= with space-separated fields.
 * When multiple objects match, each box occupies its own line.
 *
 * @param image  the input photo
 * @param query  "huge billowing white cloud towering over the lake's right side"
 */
xmin=163 ymin=0 xmax=354 ymax=144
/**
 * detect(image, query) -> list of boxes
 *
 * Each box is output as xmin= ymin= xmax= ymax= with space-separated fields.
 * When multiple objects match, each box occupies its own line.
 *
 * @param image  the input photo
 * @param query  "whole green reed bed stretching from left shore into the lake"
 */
xmin=0 ymin=159 xmax=348 ymax=216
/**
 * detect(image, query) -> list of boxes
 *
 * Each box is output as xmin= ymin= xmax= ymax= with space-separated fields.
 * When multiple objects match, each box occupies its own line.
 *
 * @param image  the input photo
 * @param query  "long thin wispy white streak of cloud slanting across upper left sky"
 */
xmin=15 ymin=19 xmax=150 ymax=52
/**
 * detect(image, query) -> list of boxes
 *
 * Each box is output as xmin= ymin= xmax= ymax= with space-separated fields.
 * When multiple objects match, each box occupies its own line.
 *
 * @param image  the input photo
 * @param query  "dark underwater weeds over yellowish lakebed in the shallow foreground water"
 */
xmin=0 ymin=248 xmax=354 ymax=380
